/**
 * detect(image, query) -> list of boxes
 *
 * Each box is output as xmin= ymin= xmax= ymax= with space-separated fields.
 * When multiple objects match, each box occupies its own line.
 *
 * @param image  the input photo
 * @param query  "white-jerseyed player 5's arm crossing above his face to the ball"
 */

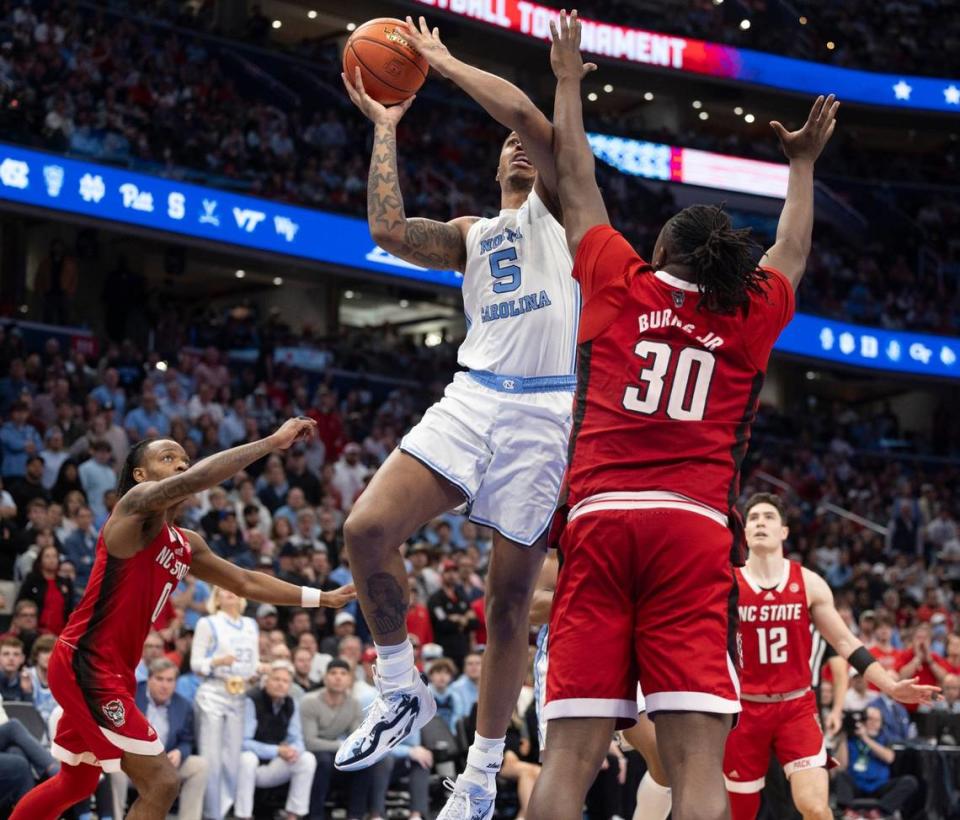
xmin=407 ymin=16 xmax=560 ymax=219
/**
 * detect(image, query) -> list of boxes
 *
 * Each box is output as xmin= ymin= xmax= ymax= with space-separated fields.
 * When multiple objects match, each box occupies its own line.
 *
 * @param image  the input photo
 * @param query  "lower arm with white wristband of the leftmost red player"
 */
xmin=185 ymin=530 xmax=357 ymax=609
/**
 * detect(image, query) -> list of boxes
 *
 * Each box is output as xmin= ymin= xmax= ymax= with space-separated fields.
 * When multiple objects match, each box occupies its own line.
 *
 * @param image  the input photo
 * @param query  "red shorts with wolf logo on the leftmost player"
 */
xmin=48 ymin=641 xmax=163 ymax=772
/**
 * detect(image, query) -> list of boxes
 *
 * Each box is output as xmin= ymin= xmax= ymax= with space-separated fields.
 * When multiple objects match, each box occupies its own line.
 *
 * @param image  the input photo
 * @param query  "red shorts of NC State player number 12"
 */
xmin=723 ymin=691 xmax=827 ymax=794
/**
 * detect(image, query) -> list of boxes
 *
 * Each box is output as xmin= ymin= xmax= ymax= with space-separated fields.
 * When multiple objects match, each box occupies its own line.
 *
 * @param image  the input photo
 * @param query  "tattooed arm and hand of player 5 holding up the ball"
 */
xmin=340 ymin=68 xmax=475 ymax=271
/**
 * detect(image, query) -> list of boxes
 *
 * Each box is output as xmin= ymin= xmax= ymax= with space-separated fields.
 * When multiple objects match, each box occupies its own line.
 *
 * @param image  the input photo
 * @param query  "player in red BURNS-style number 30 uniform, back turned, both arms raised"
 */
xmin=527 ymin=13 xmax=838 ymax=820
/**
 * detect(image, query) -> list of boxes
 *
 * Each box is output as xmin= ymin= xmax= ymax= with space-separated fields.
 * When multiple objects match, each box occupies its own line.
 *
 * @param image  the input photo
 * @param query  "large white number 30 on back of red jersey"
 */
xmin=623 ymin=339 xmax=716 ymax=421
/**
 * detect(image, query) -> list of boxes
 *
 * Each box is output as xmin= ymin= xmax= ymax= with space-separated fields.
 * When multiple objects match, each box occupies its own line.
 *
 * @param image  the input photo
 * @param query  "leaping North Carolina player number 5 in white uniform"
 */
xmin=336 ymin=18 xmax=580 ymax=820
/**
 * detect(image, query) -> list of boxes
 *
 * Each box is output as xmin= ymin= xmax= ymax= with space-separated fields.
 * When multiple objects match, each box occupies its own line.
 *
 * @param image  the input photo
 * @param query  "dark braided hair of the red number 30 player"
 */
xmin=667 ymin=205 xmax=769 ymax=314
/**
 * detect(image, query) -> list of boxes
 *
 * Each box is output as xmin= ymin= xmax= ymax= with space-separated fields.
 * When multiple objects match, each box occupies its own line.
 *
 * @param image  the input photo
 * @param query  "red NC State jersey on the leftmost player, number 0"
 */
xmin=60 ymin=524 xmax=190 ymax=691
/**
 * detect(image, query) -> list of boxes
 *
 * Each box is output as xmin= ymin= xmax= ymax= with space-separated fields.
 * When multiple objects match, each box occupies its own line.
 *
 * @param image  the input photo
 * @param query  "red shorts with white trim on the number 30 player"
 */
xmin=544 ymin=493 xmax=740 ymax=728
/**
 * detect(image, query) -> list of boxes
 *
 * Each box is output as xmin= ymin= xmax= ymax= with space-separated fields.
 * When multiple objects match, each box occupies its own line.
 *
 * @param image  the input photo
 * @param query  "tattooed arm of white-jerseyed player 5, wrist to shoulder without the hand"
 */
xmin=367 ymin=124 xmax=466 ymax=270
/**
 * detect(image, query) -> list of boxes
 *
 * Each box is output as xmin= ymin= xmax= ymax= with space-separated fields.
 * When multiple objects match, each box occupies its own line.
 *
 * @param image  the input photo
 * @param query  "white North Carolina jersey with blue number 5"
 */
xmin=458 ymin=191 xmax=580 ymax=377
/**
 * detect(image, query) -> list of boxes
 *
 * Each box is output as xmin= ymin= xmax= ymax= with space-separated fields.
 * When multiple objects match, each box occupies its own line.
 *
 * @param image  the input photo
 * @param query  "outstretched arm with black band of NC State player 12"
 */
xmin=803 ymin=569 xmax=940 ymax=703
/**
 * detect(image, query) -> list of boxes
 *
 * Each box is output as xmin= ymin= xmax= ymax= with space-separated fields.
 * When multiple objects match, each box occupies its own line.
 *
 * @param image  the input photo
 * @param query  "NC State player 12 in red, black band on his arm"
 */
xmin=723 ymin=493 xmax=939 ymax=820
